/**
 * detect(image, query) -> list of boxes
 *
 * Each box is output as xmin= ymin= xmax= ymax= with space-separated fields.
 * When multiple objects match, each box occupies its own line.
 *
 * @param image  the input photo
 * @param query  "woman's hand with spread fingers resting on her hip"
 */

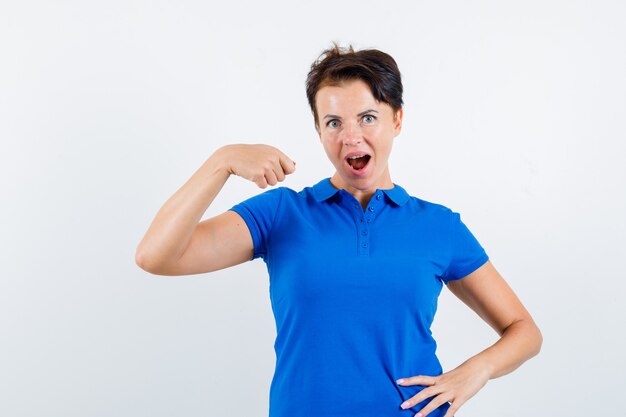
xmin=396 ymin=361 xmax=489 ymax=417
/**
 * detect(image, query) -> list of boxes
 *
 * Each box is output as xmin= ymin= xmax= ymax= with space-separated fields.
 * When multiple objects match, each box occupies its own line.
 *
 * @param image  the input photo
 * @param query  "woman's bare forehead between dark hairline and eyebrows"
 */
xmin=315 ymin=79 xmax=378 ymax=112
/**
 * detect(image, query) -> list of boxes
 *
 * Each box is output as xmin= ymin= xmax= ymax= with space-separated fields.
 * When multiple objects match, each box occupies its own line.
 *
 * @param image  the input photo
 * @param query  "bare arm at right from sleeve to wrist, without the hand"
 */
xmin=448 ymin=261 xmax=543 ymax=379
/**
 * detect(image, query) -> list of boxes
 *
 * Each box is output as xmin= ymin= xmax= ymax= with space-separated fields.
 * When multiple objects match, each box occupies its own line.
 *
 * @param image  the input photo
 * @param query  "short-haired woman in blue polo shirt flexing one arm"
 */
xmin=136 ymin=45 xmax=542 ymax=417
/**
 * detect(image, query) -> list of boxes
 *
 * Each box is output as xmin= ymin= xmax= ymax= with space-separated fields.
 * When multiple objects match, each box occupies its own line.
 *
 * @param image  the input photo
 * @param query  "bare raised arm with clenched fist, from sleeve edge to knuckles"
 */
xmin=135 ymin=144 xmax=295 ymax=275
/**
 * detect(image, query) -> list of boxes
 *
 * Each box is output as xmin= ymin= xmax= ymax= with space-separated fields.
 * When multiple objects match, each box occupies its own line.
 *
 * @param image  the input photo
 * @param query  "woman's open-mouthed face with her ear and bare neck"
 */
xmin=315 ymin=79 xmax=402 ymax=194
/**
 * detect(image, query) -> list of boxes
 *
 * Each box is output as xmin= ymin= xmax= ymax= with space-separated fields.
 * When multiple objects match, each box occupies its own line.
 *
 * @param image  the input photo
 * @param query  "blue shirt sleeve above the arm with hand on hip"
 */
xmin=441 ymin=212 xmax=489 ymax=285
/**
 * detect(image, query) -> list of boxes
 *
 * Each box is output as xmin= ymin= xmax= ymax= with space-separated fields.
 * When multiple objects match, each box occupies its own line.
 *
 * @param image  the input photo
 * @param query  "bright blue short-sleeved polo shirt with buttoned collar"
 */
xmin=231 ymin=178 xmax=489 ymax=417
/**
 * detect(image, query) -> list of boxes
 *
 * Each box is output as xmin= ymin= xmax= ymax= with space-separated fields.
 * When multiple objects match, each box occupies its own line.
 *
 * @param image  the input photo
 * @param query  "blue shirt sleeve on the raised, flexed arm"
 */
xmin=229 ymin=187 xmax=284 ymax=260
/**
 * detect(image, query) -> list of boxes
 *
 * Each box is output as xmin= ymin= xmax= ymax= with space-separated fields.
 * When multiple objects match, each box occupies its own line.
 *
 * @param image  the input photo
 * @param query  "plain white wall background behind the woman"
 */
xmin=0 ymin=0 xmax=626 ymax=417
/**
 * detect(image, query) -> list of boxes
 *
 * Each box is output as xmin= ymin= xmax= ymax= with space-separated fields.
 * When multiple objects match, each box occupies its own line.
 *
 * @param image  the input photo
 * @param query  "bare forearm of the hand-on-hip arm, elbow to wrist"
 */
xmin=466 ymin=320 xmax=543 ymax=379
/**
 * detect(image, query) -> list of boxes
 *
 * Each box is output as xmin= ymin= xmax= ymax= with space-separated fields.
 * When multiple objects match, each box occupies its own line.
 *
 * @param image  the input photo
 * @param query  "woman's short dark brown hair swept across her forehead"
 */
xmin=306 ymin=42 xmax=403 ymax=128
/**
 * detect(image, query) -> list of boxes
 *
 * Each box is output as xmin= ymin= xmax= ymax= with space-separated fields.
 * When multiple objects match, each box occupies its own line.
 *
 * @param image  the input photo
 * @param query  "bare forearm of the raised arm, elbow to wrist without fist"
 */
xmin=135 ymin=148 xmax=230 ymax=265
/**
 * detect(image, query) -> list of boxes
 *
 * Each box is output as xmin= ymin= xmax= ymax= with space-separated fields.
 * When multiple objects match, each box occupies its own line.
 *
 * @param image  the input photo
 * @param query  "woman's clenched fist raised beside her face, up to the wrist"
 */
xmin=217 ymin=144 xmax=296 ymax=188
